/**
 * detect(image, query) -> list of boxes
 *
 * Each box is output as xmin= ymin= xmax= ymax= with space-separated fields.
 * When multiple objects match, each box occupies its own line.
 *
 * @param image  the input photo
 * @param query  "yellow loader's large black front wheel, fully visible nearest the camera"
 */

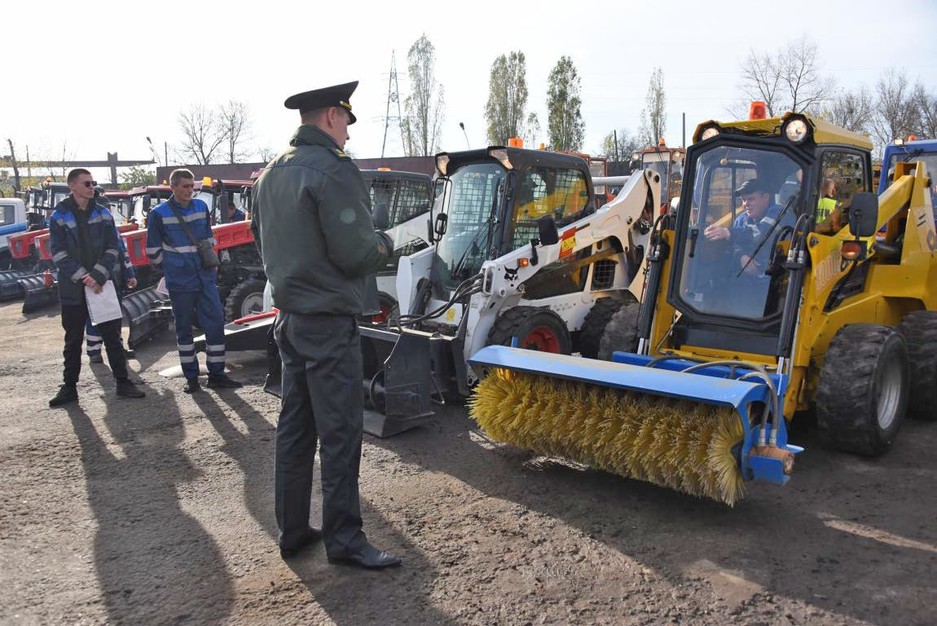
xmin=816 ymin=324 xmax=909 ymax=456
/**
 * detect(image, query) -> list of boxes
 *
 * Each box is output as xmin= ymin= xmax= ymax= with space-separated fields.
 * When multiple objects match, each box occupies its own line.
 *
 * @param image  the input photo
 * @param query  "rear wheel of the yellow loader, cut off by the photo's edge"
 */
xmin=898 ymin=311 xmax=937 ymax=422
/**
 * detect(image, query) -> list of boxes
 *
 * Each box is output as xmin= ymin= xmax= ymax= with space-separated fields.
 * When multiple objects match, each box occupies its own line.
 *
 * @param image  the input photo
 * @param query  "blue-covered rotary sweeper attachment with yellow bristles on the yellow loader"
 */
xmin=469 ymin=346 xmax=803 ymax=505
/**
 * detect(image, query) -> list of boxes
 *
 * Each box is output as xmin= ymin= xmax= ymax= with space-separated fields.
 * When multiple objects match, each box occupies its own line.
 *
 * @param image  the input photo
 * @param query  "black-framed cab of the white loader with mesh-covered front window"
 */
xmin=432 ymin=146 xmax=594 ymax=290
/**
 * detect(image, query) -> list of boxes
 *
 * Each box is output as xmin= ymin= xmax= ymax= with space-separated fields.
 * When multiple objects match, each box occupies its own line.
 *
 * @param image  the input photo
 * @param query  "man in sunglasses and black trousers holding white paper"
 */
xmin=49 ymin=168 xmax=145 ymax=407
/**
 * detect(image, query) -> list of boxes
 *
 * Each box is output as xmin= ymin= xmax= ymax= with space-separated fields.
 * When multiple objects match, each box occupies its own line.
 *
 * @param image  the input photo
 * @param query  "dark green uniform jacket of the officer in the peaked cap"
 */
xmin=251 ymin=125 xmax=393 ymax=315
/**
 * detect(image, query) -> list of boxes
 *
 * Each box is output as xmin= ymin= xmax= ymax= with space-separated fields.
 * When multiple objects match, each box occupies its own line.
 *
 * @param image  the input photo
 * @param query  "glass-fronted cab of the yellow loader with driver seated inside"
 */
xmin=667 ymin=116 xmax=871 ymax=355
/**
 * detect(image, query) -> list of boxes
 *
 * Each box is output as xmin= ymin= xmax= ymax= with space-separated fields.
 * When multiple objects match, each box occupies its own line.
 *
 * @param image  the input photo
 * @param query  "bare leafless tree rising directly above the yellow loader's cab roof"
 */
xmin=741 ymin=36 xmax=835 ymax=117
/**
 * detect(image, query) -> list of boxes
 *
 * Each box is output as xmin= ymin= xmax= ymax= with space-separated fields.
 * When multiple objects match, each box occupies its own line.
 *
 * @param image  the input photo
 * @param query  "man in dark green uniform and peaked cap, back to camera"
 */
xmin=251 ymin=82 xmax=400 ymax=568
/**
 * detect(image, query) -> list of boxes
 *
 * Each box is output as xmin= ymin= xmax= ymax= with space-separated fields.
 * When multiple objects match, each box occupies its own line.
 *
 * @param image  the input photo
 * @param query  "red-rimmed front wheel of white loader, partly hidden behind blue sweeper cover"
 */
xmin=488 ymin=306 xmax=573 ymax=354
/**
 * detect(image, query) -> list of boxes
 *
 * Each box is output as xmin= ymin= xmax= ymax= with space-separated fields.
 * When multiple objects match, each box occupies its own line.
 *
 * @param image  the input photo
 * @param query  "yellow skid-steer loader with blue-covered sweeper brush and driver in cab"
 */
xmin=469 ymin=108 xmax=937 ymax=505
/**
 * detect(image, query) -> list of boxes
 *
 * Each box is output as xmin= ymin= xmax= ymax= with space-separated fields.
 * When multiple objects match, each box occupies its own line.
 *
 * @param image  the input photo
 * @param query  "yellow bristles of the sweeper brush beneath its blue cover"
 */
xmin=469 ymin=369 xmax=745 ymax=506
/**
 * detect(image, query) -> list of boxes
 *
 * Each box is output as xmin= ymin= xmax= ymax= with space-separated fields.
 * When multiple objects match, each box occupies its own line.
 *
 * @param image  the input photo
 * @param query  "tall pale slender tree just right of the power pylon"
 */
xmin=401 ymin=34 xmax=445 ymax=156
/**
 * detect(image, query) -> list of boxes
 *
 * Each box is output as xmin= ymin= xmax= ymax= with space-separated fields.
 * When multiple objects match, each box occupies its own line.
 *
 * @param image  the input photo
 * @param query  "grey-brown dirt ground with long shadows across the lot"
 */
xmin=0 ymin=302 xmax=937 ymax=625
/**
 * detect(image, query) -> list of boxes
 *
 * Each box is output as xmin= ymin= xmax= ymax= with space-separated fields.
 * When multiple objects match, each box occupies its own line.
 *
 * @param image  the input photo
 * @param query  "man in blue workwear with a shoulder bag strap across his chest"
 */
xmin=146 ymin=169 xmax=241 ymax=393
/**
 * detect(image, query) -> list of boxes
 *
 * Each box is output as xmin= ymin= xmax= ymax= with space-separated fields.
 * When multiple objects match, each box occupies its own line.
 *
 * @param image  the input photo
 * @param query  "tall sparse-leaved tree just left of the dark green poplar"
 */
xmin=485 ymin=50 xmax=527 ymax=146
